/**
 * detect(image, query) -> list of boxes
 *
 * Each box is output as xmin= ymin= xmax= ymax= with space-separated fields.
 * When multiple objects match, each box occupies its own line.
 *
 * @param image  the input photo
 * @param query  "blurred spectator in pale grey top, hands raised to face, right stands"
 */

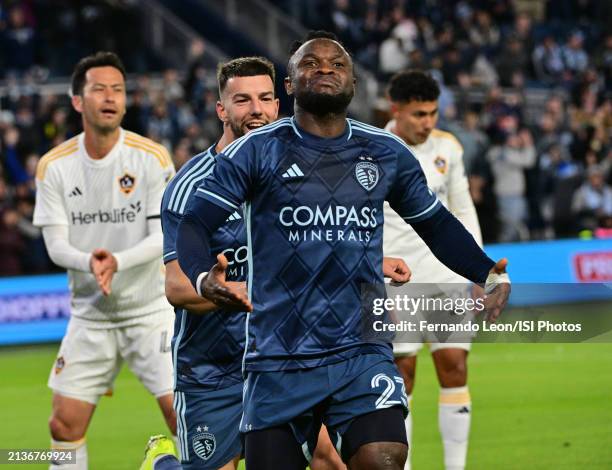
xmin=487 ymin=129 xmax=536 ymax=242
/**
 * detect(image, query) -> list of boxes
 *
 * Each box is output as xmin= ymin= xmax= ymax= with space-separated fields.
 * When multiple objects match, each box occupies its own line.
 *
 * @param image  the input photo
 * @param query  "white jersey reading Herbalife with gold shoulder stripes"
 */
xmin=34 ymin=129 xmax=174 ymax=327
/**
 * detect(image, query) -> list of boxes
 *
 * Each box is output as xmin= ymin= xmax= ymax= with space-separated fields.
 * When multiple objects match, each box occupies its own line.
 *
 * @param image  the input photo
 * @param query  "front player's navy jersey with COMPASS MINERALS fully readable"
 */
xmin=192 ymin=118 xmax=441 ymax=371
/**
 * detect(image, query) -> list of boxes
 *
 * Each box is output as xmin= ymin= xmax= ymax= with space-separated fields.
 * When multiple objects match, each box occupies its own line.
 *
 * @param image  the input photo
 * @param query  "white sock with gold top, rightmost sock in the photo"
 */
xmin=438 ymin=386 xmax=472 ymax=470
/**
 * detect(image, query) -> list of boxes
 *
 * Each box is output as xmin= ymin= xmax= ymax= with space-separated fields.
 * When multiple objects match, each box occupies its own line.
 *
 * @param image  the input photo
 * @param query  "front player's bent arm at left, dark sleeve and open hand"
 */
xmin=176 ymin=197 xmax=252 ymax=311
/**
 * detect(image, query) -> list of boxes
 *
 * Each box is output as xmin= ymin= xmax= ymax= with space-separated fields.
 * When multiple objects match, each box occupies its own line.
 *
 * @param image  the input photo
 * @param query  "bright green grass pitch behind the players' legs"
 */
xmin=0 ymin=343 xmax=612 ymax=470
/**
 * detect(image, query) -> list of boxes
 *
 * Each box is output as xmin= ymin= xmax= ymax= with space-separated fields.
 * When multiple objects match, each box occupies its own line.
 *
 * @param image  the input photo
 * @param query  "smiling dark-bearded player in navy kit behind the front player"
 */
xmin=155 ymin=57 xmax=409 ymax=470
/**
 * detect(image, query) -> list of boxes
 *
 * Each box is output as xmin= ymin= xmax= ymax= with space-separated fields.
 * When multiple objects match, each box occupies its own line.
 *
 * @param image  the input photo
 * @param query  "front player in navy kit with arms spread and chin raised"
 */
xmin=176 ymin=33 xmax=510 ymax=470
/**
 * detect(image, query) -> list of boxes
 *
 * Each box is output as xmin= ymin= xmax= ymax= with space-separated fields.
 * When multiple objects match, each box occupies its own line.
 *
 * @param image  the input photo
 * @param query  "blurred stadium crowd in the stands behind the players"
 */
xmin=0 ymin=0 xmax=612 ymax=275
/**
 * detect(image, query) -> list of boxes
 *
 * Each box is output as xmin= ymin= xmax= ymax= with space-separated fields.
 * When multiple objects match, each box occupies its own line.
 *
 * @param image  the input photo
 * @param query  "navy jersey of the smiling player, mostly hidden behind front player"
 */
xmin=161 ymin=146 xmax=247 ymax=391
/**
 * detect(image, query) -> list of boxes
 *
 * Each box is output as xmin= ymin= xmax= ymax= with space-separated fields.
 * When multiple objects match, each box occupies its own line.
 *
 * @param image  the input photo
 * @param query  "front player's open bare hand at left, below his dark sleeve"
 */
xmin=200 ymin=254 xmax=253 ymax=312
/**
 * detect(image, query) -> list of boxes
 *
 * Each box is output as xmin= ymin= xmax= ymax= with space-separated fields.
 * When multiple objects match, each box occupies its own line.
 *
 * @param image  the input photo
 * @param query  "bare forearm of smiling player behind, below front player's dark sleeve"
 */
xmin=166 ymin=260 xmax=246 ymax=314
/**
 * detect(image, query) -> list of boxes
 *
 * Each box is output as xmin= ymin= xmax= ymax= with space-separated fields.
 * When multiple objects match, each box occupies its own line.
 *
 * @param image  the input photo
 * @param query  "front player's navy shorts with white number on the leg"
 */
xmin=240 ymin=354 xmax=408 ymax=460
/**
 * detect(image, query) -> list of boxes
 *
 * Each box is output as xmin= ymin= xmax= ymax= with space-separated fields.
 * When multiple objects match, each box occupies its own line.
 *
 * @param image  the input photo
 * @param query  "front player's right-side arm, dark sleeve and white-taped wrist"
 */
xmin=412 ymin=206 xmax=510 ymax=322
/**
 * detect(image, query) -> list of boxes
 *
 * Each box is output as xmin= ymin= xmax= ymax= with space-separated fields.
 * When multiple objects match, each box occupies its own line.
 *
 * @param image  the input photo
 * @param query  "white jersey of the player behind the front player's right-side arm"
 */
xmin=383 ymin=121 xmax=482 ymax=283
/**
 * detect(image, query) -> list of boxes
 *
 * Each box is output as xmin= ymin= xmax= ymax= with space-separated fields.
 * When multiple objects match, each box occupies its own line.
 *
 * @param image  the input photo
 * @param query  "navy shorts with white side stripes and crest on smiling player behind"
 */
xmin=174 ymin=384 xmax=243 ymax=470
